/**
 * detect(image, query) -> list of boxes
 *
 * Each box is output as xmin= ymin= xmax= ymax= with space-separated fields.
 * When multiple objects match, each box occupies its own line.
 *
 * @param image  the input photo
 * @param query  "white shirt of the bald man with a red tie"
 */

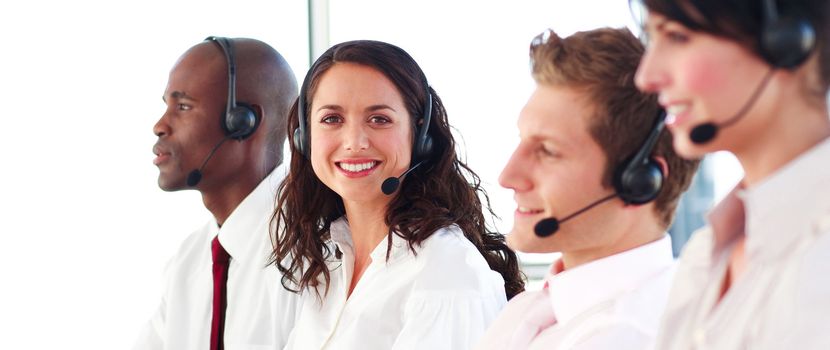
xmin=134 ymin=167 xmax=299 ymax=350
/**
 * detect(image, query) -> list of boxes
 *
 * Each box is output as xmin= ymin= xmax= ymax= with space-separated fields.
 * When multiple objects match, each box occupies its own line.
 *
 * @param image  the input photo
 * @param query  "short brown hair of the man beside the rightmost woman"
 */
xmin=530 ymin=28 xmax=699 ymax=227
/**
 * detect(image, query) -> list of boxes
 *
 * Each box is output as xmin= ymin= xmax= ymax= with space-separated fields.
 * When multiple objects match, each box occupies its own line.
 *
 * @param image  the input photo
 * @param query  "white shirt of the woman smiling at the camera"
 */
xmin=286 ymin=218 xmax=506 ymax=350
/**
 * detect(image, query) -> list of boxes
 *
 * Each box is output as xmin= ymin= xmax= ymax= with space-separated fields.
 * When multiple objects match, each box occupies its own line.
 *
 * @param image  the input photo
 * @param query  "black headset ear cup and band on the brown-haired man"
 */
xmin=614 ymin=109 xmax=666 ymax=205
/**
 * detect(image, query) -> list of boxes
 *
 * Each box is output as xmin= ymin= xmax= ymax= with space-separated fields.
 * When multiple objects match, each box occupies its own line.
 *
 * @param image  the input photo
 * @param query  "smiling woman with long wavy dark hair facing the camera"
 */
xmin=273 ymin=41 xmax=524 ymax=349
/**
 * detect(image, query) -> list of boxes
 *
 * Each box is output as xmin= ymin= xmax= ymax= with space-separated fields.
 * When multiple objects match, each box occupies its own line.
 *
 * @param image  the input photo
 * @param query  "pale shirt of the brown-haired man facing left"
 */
xmin=476 ymin=235 xmax=674 ymax=350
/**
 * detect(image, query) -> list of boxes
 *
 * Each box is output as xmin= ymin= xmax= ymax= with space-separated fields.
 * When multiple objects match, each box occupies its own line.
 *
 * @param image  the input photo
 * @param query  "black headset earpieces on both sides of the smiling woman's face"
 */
xmin=293 ymin=63 xmax=432 ymax=162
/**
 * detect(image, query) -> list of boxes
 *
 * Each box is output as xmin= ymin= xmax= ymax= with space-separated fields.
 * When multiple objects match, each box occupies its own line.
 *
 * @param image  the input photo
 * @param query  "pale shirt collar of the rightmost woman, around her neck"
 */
xmin=709 ymin=139 xmax=830 ymax=258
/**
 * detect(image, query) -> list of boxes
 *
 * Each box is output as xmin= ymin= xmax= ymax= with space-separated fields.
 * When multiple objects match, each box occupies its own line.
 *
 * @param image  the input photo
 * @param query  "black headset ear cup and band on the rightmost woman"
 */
xmin=759 ymin=0 xmax=816 ymax=69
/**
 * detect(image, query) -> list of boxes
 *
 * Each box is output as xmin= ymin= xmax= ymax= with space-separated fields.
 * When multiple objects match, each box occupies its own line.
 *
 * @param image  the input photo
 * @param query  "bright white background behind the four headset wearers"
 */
xmin=0 ymin=0 xmax=739 ymax=349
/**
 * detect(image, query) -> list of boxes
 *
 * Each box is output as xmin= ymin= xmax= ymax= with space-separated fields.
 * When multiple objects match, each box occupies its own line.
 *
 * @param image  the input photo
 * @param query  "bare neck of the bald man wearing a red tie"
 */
xmin=200 ymin=168 xmax=273 ymax=226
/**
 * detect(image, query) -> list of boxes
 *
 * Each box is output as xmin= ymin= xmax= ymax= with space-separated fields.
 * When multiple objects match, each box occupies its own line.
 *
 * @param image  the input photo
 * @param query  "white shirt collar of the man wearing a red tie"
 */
xmin=216 ymin=165 xmax=286 ymax=266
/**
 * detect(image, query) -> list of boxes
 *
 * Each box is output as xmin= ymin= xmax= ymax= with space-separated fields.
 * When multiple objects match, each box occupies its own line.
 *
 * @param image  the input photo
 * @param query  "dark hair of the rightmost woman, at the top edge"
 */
xmin=630 ymin=0 xmax=830 ymax=95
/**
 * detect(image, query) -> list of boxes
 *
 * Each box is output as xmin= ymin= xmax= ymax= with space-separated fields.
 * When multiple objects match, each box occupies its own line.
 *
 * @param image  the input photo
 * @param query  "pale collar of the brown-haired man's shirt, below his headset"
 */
xmin=546 ymin=235 xmax=674 ymax=324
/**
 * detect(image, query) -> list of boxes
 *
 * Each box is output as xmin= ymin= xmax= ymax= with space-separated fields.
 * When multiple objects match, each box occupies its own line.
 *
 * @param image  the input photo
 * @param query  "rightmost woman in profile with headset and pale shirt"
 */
xmin=636 ymin=0 xmax=830 ymax=349
